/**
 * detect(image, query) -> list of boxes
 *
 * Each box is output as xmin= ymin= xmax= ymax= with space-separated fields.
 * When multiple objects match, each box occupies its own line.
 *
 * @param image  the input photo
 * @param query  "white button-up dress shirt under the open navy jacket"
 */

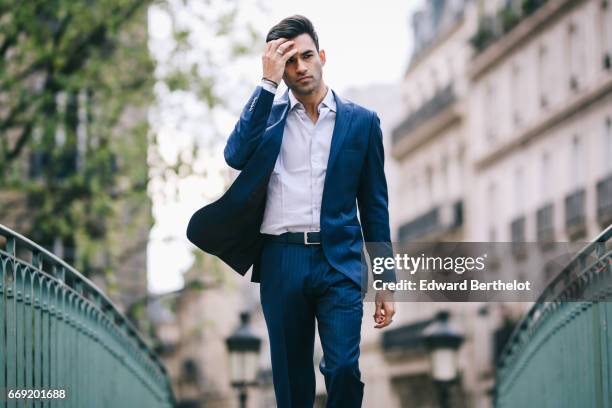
xmin=260 ymin=81 xmax=336 ymax=235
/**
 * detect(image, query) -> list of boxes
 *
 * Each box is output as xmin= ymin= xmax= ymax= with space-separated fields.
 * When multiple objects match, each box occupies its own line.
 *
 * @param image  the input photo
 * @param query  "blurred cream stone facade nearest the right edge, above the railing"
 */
xmin=467 ymin=0 xmax=612 ymax=241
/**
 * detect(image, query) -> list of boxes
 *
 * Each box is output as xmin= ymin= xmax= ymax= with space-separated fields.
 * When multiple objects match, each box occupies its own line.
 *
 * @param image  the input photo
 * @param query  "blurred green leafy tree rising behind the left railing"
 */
xmin=0 ymin=0 xmax=258 ymax=300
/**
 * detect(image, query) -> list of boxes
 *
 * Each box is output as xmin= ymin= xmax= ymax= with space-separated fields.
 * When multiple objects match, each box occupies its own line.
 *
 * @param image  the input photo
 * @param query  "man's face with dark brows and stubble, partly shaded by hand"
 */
xmin=283 ymin=33 xmax=325 ymax=95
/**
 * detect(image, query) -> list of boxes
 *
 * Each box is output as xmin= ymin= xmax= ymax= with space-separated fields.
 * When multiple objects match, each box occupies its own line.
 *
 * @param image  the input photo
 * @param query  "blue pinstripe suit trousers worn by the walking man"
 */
xmin=260 ymin=241 xmax=364 ymax=408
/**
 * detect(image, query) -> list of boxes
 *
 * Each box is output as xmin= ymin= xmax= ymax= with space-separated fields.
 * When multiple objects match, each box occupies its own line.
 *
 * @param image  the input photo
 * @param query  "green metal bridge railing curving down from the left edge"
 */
xmin=0 ymin=225 xmax=174 ymax=408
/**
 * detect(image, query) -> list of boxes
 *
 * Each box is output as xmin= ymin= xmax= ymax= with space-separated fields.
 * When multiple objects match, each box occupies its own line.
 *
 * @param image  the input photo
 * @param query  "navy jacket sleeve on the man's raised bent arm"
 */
xmin=223 ymin=85 xmax=274 ymax=170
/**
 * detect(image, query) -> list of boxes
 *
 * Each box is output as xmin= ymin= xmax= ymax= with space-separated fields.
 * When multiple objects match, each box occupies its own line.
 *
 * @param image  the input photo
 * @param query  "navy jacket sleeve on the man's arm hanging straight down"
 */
xmin=357 ymin=113 xmax=396 ymax=282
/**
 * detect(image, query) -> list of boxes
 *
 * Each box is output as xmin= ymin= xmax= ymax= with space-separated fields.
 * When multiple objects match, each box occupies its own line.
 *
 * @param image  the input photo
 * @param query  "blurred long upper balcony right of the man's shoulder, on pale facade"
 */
xmin=392 ymin=84 xmax=458 ymax=155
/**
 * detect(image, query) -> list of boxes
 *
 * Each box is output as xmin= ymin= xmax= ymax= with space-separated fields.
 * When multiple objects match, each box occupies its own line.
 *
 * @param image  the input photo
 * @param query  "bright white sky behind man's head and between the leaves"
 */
xmin=147 ymin=0 xmax=423 ymax=293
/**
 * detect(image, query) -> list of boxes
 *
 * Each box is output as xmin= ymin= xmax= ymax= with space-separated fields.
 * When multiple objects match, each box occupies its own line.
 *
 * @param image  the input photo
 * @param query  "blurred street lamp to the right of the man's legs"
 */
xmin=423 ymin=310 xmax=464 ymax=408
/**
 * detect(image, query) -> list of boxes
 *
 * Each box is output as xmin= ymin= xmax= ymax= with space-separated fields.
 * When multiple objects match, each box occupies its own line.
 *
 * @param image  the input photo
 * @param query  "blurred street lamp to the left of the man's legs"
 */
xmin=225 ymin=312 xmax=261 ymax=408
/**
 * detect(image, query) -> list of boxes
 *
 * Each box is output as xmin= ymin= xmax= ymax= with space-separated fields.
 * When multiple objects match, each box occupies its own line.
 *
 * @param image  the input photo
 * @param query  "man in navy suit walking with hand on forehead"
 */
xmin=187 ymin=15 xmax=395 ymax=408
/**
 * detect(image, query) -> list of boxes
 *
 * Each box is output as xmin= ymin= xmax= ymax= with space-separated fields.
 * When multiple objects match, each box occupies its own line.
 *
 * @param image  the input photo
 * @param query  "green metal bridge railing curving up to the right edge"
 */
xmin=495 ymin=226 xmax=612 ymax=408
